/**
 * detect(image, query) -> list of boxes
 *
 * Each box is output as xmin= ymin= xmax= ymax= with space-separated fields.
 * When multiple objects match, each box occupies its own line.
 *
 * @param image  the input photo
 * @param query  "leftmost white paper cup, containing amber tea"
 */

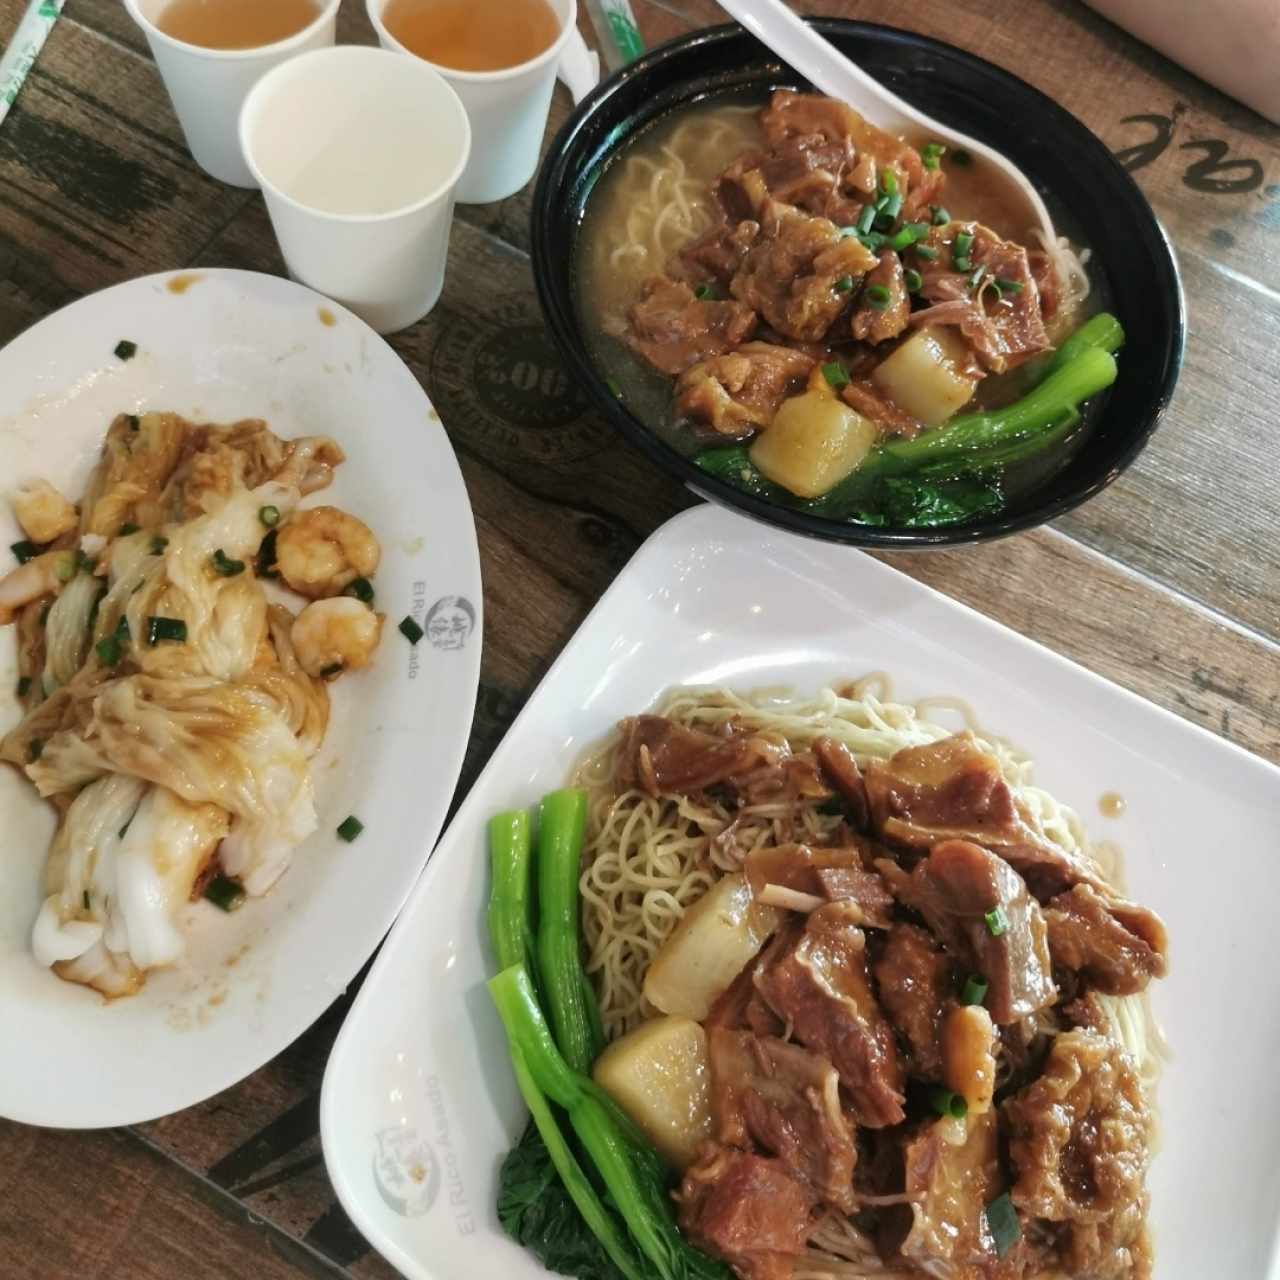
xmin=124 ymin=0 xmax=342 ymax=187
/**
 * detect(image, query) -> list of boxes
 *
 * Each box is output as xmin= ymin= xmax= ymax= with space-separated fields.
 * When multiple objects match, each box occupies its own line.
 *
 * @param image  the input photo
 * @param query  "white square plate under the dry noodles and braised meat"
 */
xmin=320 ymin=507 xmax=1280 ymax=1280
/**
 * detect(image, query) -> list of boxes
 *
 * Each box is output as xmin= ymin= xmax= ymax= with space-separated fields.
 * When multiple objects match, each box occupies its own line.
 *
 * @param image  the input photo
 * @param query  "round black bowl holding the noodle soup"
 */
xmin=532 ymin=19 xmax=1185 ymax=548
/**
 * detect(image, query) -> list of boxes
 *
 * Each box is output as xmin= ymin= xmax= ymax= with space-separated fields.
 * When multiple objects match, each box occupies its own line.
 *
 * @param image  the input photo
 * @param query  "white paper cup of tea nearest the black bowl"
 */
xmin=365 ymin=0 xmax=581 ymax=205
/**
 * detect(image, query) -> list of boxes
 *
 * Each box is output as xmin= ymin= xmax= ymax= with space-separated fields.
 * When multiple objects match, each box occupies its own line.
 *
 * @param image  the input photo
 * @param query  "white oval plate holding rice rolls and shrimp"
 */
xmin=0 ymin=270 xmax=481 ymax=1128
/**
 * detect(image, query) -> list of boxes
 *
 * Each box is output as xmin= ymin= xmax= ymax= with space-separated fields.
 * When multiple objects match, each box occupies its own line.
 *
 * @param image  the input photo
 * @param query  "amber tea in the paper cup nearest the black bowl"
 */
xmin=383 ymin=0 xmax=561 ymax=72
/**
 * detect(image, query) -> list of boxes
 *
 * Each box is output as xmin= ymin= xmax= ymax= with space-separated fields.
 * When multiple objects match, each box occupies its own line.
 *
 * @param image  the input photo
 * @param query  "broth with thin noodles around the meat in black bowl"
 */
xmin=575 ymin=97 xmax=1106 ymax=509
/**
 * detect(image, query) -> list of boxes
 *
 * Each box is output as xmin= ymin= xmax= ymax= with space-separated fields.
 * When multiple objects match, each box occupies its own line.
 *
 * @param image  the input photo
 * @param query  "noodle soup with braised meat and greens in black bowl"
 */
xmin=576 ymin=91 xmax=1123 ymax=525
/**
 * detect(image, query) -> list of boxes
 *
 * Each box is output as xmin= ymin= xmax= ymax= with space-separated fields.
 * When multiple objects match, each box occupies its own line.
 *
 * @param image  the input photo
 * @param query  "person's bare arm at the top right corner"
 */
xmin=1085 ymin=0 xmax=1280 ymax=124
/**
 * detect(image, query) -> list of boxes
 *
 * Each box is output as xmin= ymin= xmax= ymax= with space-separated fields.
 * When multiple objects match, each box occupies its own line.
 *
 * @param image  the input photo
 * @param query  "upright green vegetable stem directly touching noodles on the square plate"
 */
xmin=538 ymin=788 xmax=604 ymax=1075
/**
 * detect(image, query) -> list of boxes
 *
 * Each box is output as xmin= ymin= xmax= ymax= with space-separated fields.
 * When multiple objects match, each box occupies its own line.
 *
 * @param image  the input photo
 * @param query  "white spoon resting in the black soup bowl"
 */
xmin=719 ymin=0 xmax=1056 ymax=246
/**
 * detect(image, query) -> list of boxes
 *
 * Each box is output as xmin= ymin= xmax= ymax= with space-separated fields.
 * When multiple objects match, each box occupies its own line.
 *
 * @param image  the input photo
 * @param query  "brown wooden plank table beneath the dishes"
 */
xmin=0 ymin=0 xmax=1280 ymax=1280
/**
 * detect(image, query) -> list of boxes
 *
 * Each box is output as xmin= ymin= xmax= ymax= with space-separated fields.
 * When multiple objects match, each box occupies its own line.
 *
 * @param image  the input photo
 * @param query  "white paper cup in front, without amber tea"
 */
xmin=239 ymin=45 xmax=471 ymax=333
